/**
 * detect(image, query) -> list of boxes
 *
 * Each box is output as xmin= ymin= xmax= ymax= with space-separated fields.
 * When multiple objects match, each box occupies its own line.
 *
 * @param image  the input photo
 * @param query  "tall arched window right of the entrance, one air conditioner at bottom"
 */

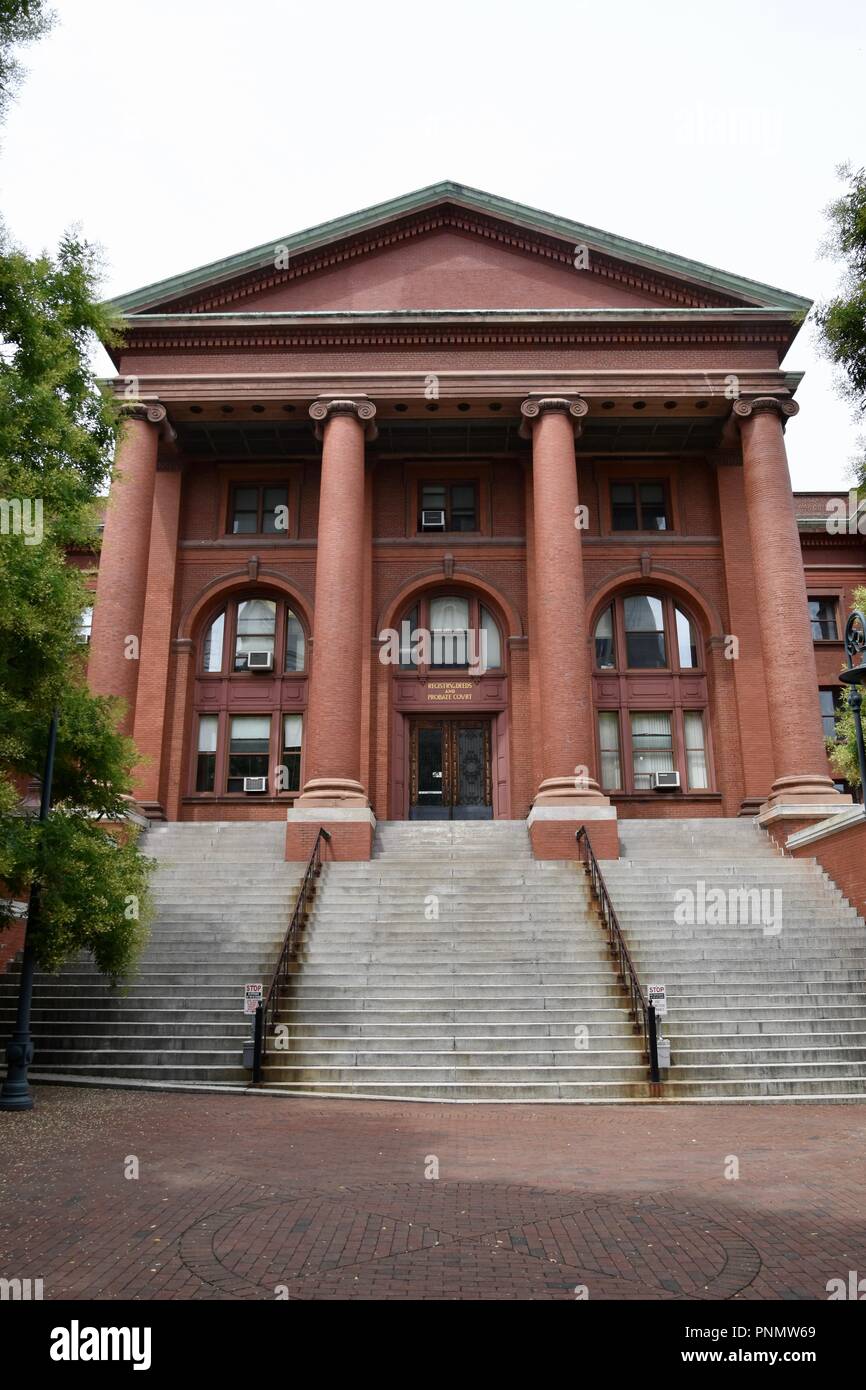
xmin=594 ymin=592 xmax=712 ymax=795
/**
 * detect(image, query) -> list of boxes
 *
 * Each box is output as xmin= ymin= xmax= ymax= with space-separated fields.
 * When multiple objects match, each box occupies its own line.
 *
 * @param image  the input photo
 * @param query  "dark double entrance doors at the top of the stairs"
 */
xmin=409 ymin=717 xmax=493 ymax=820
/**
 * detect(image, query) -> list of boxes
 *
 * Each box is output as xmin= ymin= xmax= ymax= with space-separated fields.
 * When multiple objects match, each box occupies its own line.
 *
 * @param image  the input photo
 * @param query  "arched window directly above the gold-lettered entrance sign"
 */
xmin=399 ymin=594 xmax=503 ymax=673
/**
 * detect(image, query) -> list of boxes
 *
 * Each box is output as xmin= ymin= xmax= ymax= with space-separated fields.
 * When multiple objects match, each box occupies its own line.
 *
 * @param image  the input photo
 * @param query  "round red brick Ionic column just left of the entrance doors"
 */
xmin=296 ymin=400 xmax=375 ymax=808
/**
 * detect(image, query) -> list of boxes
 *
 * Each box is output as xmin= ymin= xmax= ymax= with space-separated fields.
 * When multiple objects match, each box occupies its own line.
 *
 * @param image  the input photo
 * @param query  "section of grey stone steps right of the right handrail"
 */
xmin=601 ymin=819 xmax=866 ymax=1101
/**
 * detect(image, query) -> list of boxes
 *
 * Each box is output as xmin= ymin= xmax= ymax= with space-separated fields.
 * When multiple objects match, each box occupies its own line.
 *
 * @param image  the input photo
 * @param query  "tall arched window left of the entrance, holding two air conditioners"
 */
xmin=190 ymin=594 xmax=306 ymax=798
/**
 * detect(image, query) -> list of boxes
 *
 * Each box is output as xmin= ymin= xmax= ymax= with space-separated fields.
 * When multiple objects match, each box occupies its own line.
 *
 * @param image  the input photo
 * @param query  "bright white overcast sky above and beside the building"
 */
xmin=0 ymin=0 xmax=866 ymax=488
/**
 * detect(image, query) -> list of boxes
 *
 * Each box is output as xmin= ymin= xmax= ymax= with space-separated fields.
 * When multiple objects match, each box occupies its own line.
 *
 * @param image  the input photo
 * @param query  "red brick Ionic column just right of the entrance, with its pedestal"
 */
xmin=520 ymin=396 xmax=616 ymax=858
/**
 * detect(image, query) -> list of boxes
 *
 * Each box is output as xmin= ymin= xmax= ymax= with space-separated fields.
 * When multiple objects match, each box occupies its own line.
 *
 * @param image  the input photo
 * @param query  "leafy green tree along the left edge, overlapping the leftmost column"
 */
xmin=0 ymin=0 xmax=149 ymax=976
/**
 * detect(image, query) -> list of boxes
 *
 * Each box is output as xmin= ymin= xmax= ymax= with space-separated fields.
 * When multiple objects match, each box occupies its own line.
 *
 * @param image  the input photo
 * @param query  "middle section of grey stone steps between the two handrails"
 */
xmin=264 ymin=820 xmax=649 ymax=1101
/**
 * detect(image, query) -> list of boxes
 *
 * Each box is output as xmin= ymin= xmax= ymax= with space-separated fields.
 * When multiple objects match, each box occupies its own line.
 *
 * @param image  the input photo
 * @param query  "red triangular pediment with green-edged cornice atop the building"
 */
xmin=113 ymin=183 xmax=809 ymax=316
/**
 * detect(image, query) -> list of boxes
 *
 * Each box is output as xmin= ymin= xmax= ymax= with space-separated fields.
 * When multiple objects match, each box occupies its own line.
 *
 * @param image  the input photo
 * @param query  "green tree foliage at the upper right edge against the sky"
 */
xmin=816 ymin=164 xmax=866 ymax=487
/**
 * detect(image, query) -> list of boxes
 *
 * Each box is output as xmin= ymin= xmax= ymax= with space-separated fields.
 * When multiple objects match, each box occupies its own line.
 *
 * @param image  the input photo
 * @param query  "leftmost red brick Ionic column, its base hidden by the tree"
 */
xmin=88 ymin=404 xmax=165 ymax=733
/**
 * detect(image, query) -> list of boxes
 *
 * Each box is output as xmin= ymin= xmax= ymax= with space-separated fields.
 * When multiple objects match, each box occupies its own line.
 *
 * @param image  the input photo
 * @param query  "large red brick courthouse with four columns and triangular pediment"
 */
xmin=90 ymin=183 xmax=866 ymax=859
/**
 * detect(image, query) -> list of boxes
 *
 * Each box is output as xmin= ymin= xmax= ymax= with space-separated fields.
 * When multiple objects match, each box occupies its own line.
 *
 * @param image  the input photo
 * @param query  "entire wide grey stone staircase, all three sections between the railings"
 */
xmin=0 ymin=819 xmax=866 ymax=1102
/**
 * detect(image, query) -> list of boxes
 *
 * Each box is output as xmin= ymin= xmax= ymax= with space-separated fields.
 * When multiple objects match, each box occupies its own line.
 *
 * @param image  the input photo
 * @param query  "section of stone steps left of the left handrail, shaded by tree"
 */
xmin=0 ymin=821 xmax=302 ymax=1084
